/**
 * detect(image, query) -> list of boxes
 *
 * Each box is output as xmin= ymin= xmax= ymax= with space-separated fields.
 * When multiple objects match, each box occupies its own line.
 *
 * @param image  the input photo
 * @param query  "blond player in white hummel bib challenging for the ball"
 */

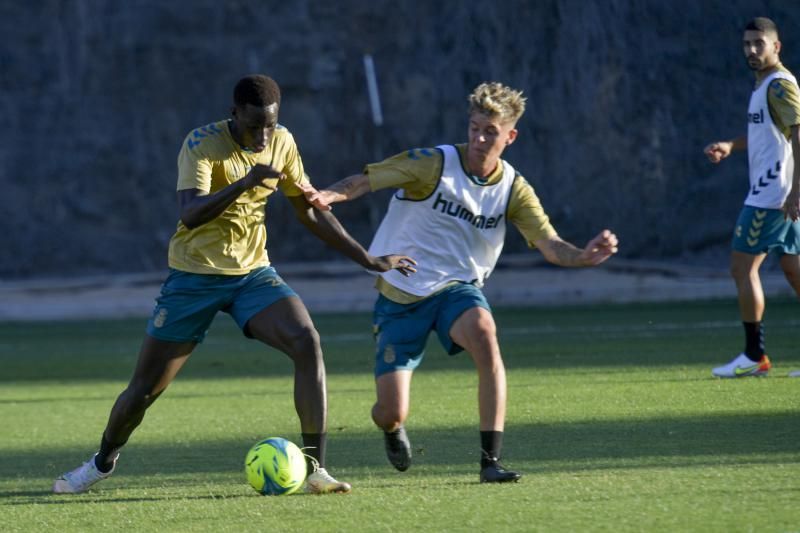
xmin=304 ymin=82 xmax=617 ymax=483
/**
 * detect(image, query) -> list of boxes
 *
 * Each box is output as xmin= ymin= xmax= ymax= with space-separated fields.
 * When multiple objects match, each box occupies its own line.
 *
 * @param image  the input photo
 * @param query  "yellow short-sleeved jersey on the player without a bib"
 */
xmin=169 ymin=120 xmax=305 ymax=275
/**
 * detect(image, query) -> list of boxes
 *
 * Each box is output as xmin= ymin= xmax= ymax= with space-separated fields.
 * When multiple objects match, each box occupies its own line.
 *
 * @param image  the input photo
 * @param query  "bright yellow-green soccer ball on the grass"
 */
xmin=244 ymin=437 xmax=306 ymax=496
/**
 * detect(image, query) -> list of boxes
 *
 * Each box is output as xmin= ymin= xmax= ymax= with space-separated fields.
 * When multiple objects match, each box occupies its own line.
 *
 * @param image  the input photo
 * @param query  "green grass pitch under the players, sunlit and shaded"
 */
xmin=0 ymin=301 xmax=800 ymax=532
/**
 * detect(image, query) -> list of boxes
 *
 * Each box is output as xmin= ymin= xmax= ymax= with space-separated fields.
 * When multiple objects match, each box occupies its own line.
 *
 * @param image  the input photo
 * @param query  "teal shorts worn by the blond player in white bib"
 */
xmin=373 ymin=283 xmax=491 ymax=377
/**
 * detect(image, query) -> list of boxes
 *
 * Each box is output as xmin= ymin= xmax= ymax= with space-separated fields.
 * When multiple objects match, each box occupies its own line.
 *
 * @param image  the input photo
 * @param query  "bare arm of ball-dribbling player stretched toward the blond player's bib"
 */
xmin=289 ymin=196 xmax=417 ymax=276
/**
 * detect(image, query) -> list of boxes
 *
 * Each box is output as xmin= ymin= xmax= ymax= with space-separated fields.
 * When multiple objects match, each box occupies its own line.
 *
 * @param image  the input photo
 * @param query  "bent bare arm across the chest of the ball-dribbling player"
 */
xmin=178 ymin=164 xmax=284 ymax=229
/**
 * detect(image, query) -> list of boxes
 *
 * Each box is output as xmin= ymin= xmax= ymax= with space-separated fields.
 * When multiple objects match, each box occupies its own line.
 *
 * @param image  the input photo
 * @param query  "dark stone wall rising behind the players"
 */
xmin=0 ymin=0 xmax=800 ymax=279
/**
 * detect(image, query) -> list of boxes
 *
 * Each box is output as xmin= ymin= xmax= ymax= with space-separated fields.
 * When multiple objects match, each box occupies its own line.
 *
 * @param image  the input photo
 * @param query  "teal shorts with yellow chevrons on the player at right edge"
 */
xmin=733 ymin=205 xmax=800 ymax=255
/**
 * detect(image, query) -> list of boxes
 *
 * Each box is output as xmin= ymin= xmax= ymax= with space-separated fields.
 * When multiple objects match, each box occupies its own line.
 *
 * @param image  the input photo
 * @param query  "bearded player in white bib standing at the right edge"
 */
xmin=704 ymin=17 xmax=800 ymax=378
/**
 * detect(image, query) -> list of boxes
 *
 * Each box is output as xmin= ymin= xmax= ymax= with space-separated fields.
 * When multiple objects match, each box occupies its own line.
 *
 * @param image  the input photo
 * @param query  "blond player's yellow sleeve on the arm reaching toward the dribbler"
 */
xmin=364 ymin=148 xmax=443 ymax=200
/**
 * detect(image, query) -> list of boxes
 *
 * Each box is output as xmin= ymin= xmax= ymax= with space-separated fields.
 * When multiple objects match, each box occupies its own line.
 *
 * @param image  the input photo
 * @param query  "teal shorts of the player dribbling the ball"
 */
xmin=147 ymin=267 xmax=297 ymax=342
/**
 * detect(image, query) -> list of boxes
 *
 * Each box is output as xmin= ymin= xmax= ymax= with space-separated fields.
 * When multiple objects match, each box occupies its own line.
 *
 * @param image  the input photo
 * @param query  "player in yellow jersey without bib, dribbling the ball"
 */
xmin=53 ymin=75 xmax=414 ymax=493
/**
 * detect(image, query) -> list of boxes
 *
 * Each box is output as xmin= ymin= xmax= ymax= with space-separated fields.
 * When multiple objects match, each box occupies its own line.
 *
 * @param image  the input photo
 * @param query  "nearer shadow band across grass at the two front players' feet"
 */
xmin=0 ymin=411 xmax=800 ymax=505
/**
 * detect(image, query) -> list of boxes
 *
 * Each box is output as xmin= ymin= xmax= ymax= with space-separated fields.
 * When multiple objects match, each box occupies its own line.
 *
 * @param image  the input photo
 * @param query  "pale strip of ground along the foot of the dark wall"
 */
xmin=0 ymin=257 xmax=793 ymax=321
